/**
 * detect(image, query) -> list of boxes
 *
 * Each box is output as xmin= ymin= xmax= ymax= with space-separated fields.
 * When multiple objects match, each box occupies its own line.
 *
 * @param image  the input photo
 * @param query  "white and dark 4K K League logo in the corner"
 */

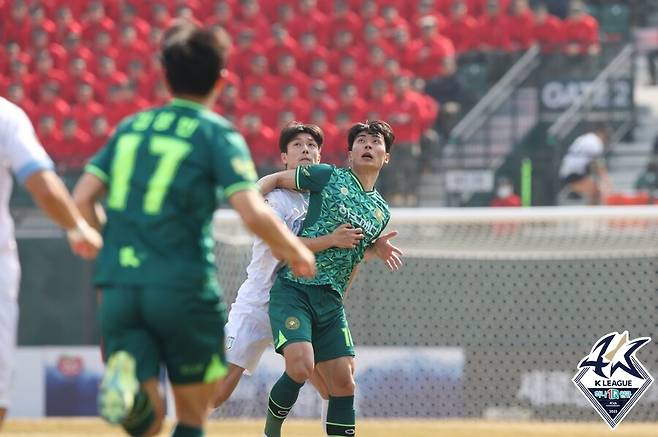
xmin=573 ymin=331 xmax=653 ymax=429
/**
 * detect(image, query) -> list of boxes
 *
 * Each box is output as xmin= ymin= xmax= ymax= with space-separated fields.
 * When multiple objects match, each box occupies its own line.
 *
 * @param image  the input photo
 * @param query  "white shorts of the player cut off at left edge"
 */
xmin=0 ymin=253 xmax=20 ymax=408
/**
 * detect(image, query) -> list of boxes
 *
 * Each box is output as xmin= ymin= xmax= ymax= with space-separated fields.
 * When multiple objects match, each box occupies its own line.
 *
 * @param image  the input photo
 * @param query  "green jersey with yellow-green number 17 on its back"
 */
xmin=85 ymin=99 xmax=257 ymax=288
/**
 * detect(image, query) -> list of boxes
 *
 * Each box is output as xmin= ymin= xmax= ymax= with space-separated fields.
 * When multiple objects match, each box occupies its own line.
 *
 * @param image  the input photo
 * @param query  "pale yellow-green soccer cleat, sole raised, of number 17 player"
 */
xmin=98 ymin=351 xmax=139 ymax=424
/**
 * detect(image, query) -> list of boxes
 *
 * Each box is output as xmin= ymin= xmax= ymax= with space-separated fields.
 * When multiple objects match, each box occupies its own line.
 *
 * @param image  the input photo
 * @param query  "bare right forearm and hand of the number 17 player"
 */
xmin=229 ymin=190 xmax=315 ymax=278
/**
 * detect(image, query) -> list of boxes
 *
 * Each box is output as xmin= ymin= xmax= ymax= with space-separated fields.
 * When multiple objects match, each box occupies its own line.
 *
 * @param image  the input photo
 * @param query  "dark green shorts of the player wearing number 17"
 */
xmin=99 ymin=286 xmax=227 ymax=384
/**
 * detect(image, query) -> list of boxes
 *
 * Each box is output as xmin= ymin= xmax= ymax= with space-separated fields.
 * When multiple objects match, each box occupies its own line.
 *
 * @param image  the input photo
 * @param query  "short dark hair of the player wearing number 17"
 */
xmin=161 ymin=20 xmax=230 ymax=96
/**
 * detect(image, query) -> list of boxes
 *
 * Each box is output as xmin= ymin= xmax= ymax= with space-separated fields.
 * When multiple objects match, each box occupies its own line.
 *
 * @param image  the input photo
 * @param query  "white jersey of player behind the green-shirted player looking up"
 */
xmin=234 ymin=189 xmax=308 ymax=305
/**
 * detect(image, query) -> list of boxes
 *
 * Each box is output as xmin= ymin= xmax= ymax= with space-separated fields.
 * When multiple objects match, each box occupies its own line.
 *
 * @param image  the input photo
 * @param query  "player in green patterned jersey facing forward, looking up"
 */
xmin=259 ymin=121 xmax=394 ymax=437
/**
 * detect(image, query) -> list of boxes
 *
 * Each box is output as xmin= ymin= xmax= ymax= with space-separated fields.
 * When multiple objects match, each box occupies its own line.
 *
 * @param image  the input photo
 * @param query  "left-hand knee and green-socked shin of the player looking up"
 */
xmin=265 ymin=341 xmax=314 ymax=437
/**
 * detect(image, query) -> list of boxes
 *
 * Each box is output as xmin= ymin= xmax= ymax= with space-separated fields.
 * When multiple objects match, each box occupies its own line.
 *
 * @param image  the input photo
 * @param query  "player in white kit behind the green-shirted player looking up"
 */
xmin=215 ymin=122 xmax=401 ymax=430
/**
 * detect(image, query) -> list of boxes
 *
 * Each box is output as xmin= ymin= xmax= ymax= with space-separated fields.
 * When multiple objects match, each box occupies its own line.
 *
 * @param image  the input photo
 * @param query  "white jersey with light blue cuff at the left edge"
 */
xmin=0 ymin=97 xmax=53 ymax=297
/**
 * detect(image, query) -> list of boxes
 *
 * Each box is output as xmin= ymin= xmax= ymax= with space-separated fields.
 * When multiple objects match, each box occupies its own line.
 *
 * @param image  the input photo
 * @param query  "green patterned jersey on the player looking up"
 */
xmin=280 ymin=164 xmax=391 ymax=295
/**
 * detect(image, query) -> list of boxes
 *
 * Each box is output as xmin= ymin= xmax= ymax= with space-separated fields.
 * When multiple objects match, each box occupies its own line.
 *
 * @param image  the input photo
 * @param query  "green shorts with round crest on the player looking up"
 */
xmin=269 ymin=278 xmax=354 ymax=363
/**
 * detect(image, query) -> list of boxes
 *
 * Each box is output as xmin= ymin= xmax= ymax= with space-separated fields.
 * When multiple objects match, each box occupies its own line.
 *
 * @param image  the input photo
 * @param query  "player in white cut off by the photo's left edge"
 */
xmin=0 ymin=97 xmax=103 ymax=427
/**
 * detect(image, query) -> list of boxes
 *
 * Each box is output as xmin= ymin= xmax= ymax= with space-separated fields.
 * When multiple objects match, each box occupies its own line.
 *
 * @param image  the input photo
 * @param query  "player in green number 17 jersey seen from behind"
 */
xmin=74 ymin=22 xmax=315 ymax=437
